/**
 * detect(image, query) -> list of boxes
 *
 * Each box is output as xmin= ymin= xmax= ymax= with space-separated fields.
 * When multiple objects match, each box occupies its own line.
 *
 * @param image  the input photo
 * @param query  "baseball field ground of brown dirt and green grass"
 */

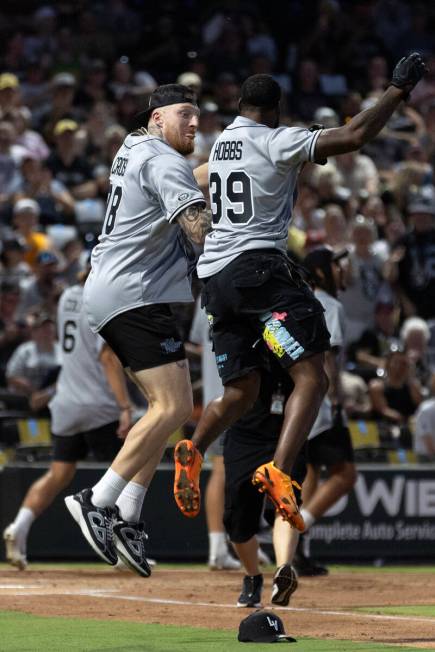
xmin=0 ymin=563 xmax=435 ymax=652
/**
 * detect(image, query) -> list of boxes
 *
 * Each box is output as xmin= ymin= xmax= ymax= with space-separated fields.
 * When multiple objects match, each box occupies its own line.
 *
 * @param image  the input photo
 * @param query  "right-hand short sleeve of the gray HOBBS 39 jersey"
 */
xmin=268 ymin=127 xmax=322 ymax=167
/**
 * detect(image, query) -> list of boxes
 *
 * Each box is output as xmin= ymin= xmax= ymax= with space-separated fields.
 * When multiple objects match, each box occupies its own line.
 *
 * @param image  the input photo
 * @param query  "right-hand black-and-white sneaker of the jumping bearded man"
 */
xmin=113 ymin=513 xmax=151 ymax=577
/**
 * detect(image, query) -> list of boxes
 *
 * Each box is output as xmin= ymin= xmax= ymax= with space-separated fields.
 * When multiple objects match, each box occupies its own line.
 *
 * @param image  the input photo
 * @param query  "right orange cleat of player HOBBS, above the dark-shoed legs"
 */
xmin=252 ymin=462 xmax=305 ymax=532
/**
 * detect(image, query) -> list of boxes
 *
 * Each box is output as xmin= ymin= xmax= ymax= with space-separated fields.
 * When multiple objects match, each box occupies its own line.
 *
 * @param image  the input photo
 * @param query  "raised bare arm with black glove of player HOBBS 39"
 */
xmin=315 ymin=52 xmax=426 ymax=161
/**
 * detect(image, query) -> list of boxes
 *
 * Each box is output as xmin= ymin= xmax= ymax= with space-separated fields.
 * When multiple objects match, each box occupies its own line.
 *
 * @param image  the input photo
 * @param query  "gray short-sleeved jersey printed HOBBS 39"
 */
xmin=198 ymin=116 xmax=321 ymax=278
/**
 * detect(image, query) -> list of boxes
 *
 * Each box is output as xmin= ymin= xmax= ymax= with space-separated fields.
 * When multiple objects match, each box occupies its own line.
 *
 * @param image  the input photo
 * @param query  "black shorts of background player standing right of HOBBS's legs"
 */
xmin=306 ymin=426 xmax=354 ymax=467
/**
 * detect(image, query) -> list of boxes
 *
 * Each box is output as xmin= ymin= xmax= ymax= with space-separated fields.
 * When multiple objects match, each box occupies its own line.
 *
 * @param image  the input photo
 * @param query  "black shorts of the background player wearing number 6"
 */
xmin=51 ymin=421 xmax=123 ymax=462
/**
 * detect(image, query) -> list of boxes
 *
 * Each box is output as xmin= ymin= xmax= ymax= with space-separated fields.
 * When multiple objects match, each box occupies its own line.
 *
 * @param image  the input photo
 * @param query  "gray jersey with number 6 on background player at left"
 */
xmin=49 ymin=285 xmax=119 ymax=435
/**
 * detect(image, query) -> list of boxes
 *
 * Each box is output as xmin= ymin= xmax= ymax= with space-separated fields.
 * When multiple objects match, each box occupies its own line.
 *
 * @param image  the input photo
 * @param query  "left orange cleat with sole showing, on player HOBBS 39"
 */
xmin=174 ymin=439 xmax=202 ymax=518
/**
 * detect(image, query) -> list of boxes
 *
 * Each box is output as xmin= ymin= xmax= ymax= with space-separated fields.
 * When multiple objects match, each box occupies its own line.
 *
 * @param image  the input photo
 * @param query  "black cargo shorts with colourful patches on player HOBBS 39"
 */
xmin=202 ymin=249 xmax=329 ymax=384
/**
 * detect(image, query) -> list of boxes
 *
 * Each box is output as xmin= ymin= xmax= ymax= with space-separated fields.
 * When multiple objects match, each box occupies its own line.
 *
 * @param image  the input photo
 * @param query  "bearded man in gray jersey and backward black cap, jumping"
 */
xmin=65 ymin=84 xmax=211 ymax=576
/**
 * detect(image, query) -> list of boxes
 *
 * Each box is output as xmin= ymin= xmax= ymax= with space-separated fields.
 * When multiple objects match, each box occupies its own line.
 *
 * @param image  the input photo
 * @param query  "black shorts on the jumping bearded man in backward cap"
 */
xmin=100 ymin=303 xmax=186 ymax=371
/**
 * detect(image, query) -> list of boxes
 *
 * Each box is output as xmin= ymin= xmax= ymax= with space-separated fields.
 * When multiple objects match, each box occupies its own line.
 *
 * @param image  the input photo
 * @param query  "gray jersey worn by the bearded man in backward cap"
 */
xmin=85 ymin=134 xmax=204 ymax=331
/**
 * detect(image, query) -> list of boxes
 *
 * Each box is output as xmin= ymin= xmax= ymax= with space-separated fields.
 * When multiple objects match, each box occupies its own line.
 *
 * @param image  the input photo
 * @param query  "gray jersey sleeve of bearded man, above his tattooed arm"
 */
xmin=141 ymin=154 xmax=205 ymax=222
